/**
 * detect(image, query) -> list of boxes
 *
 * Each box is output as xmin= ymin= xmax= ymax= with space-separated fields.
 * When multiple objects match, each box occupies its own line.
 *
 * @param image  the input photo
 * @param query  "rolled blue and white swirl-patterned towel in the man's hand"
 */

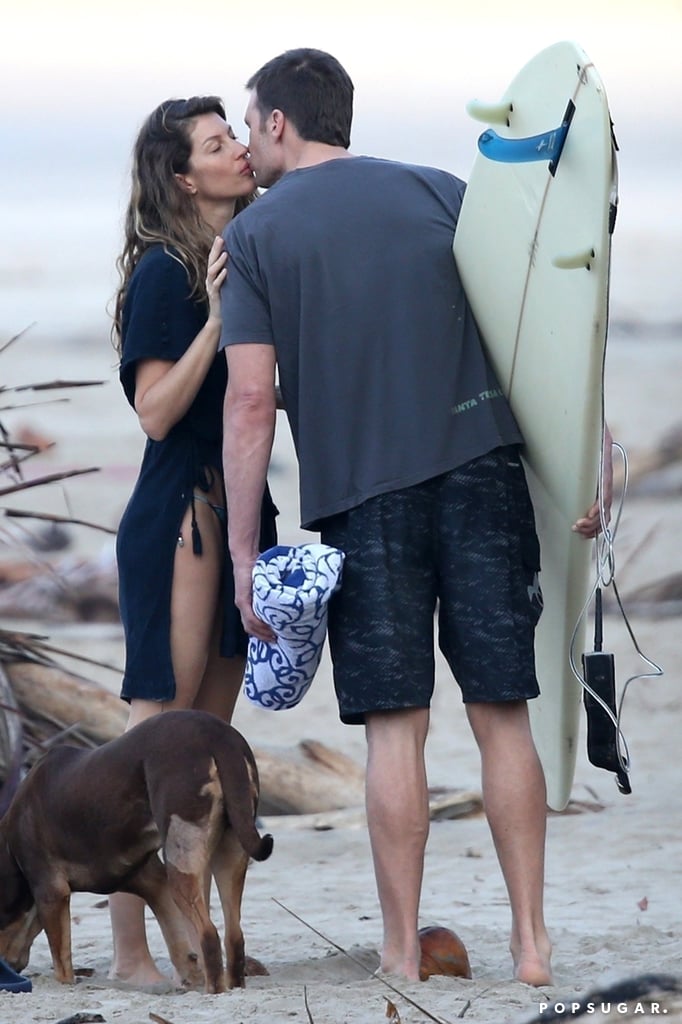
xmin=244 ymin=544 xmax=344 ymax=711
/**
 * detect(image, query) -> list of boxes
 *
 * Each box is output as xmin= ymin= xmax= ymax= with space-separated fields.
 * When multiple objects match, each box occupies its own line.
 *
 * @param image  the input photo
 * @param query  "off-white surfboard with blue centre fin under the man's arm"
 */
xmin=454 ymin=41 xmax=617 ymax=810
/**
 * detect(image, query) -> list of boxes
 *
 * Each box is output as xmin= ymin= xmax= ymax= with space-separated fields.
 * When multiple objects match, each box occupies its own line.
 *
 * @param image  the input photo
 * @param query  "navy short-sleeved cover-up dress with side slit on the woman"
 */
xmin=117 ymin=245 xmax=278 ymax=700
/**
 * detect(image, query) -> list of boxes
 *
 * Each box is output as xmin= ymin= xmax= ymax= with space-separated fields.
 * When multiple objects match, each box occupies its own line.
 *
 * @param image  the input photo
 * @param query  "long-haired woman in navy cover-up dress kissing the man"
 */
xmin=110 ymin=96 xmax=276 ymax=986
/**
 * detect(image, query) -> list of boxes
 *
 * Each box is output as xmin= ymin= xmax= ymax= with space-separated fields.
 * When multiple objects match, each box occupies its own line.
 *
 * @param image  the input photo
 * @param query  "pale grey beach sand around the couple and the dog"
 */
xmin=0 ymin=321 xmax=682 ymax=1024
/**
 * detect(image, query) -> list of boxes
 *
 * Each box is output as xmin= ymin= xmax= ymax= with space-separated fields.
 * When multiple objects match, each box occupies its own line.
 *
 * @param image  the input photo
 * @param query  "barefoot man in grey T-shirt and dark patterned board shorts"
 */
xmin=221 ymin=49 xmax=598 ymax=985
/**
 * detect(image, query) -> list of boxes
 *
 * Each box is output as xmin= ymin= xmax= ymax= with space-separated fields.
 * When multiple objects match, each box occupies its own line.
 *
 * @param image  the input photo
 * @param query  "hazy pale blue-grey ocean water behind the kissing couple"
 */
xmin=0 ymin=98 xmax=682 ymax=346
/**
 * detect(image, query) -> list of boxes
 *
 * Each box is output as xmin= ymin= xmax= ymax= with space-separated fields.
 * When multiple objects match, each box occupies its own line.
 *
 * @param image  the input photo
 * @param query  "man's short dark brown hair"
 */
xmin=247 ymin=47 xmax=353 ymax=150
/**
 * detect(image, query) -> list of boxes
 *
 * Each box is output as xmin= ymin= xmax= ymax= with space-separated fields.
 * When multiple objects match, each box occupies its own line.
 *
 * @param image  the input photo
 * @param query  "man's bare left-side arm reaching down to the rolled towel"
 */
xmin=223 ymin=344 xmax=275 ymax=642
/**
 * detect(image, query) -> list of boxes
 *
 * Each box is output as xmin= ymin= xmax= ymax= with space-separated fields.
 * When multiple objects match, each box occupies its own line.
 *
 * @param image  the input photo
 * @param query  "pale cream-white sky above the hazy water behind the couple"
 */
xmin=6 ymin=0 xmax=682 ymax=153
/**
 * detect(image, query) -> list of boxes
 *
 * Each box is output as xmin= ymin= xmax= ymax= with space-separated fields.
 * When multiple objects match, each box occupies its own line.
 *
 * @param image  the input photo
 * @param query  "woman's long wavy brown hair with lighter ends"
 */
xmin=112 ymin=96 xmax=255 ymax=355
